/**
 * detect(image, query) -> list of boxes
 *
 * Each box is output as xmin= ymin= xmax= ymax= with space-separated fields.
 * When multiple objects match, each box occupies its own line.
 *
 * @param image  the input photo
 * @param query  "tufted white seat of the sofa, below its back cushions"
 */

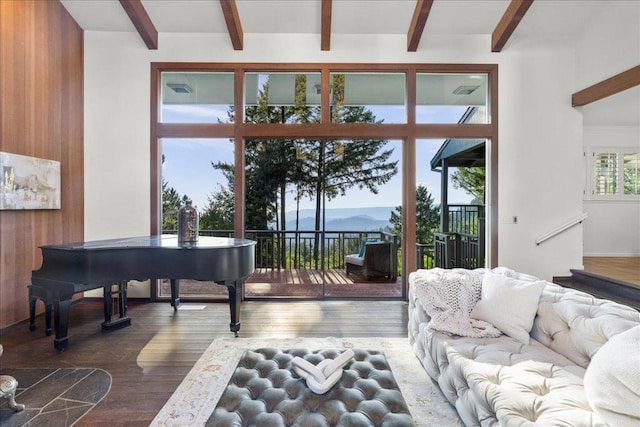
xmin=421 ymin=330 xmax=604 ymax=426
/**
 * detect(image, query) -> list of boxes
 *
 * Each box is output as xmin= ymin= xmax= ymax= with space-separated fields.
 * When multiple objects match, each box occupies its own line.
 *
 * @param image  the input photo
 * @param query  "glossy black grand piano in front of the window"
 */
xmin=29 ymin=235 xmax=256 ymax=351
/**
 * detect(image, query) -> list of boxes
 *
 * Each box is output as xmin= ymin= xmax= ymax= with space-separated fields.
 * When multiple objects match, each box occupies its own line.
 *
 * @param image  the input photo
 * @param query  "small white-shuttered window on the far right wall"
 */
xmin=588 ymin=148 xmax=640 ymax=200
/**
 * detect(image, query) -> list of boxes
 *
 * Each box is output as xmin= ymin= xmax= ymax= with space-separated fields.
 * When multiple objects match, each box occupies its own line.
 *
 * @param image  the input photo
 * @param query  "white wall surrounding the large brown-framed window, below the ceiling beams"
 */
xmin=85 ymin=32 xmax=582 ymax=296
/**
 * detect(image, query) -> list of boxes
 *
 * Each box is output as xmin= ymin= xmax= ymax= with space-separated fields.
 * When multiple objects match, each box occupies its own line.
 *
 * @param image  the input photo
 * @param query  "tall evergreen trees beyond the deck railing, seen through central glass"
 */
xmin=213 ymin=74 xmax=398 ymax=263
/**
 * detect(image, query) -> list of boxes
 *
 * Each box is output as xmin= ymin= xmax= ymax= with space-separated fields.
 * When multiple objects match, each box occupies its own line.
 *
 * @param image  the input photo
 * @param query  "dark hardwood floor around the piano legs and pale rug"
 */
xmin=0 ymin=299 xmax=408 ymax=426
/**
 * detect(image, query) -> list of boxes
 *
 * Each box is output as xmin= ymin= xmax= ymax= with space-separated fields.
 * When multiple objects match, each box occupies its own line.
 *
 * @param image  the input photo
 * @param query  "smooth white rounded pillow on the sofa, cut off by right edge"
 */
xmin=584 ymin=326 xmax=640 ymax=427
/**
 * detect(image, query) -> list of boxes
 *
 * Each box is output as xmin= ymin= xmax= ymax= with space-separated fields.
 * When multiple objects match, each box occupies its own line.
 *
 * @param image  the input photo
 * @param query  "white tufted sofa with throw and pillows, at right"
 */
xmin=409 ymin=268 xmax=640 ymax=427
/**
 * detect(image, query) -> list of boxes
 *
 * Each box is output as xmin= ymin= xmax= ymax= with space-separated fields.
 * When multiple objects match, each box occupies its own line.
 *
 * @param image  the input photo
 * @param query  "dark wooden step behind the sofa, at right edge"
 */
xmin=553 ymin=270 xmax=640 ymax=310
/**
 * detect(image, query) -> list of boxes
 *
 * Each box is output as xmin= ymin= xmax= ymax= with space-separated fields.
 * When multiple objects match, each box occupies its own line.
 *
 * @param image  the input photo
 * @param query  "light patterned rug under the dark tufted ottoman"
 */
xmin=151 ymin=337 xmax=463 ymax=426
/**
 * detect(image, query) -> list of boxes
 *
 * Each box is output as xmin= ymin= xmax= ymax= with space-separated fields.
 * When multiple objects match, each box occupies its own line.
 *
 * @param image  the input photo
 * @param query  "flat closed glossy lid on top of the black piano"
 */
xmin=40 ymin=234 xmax=256 ymax=250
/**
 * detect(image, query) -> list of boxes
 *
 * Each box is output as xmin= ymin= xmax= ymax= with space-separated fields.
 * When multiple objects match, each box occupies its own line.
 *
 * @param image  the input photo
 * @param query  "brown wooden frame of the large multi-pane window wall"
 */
xmin=150 ymin=62 xmax=499 ymax=296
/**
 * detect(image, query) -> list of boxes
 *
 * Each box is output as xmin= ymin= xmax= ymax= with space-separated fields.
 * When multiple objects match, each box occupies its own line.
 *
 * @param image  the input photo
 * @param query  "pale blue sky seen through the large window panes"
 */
xmin=162 ymin=105 xmax=472 ymax=214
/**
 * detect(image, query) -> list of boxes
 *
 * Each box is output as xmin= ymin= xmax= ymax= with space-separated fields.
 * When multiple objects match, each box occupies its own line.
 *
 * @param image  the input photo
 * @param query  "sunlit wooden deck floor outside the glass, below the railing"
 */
xmin=161 ymin=268 xmax=402 ymax=301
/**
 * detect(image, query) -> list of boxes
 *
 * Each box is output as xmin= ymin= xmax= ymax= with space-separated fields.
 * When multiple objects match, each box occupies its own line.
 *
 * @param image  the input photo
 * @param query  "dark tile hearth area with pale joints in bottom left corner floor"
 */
xmin=0 ymin=368 xmax=111 ymax=427
